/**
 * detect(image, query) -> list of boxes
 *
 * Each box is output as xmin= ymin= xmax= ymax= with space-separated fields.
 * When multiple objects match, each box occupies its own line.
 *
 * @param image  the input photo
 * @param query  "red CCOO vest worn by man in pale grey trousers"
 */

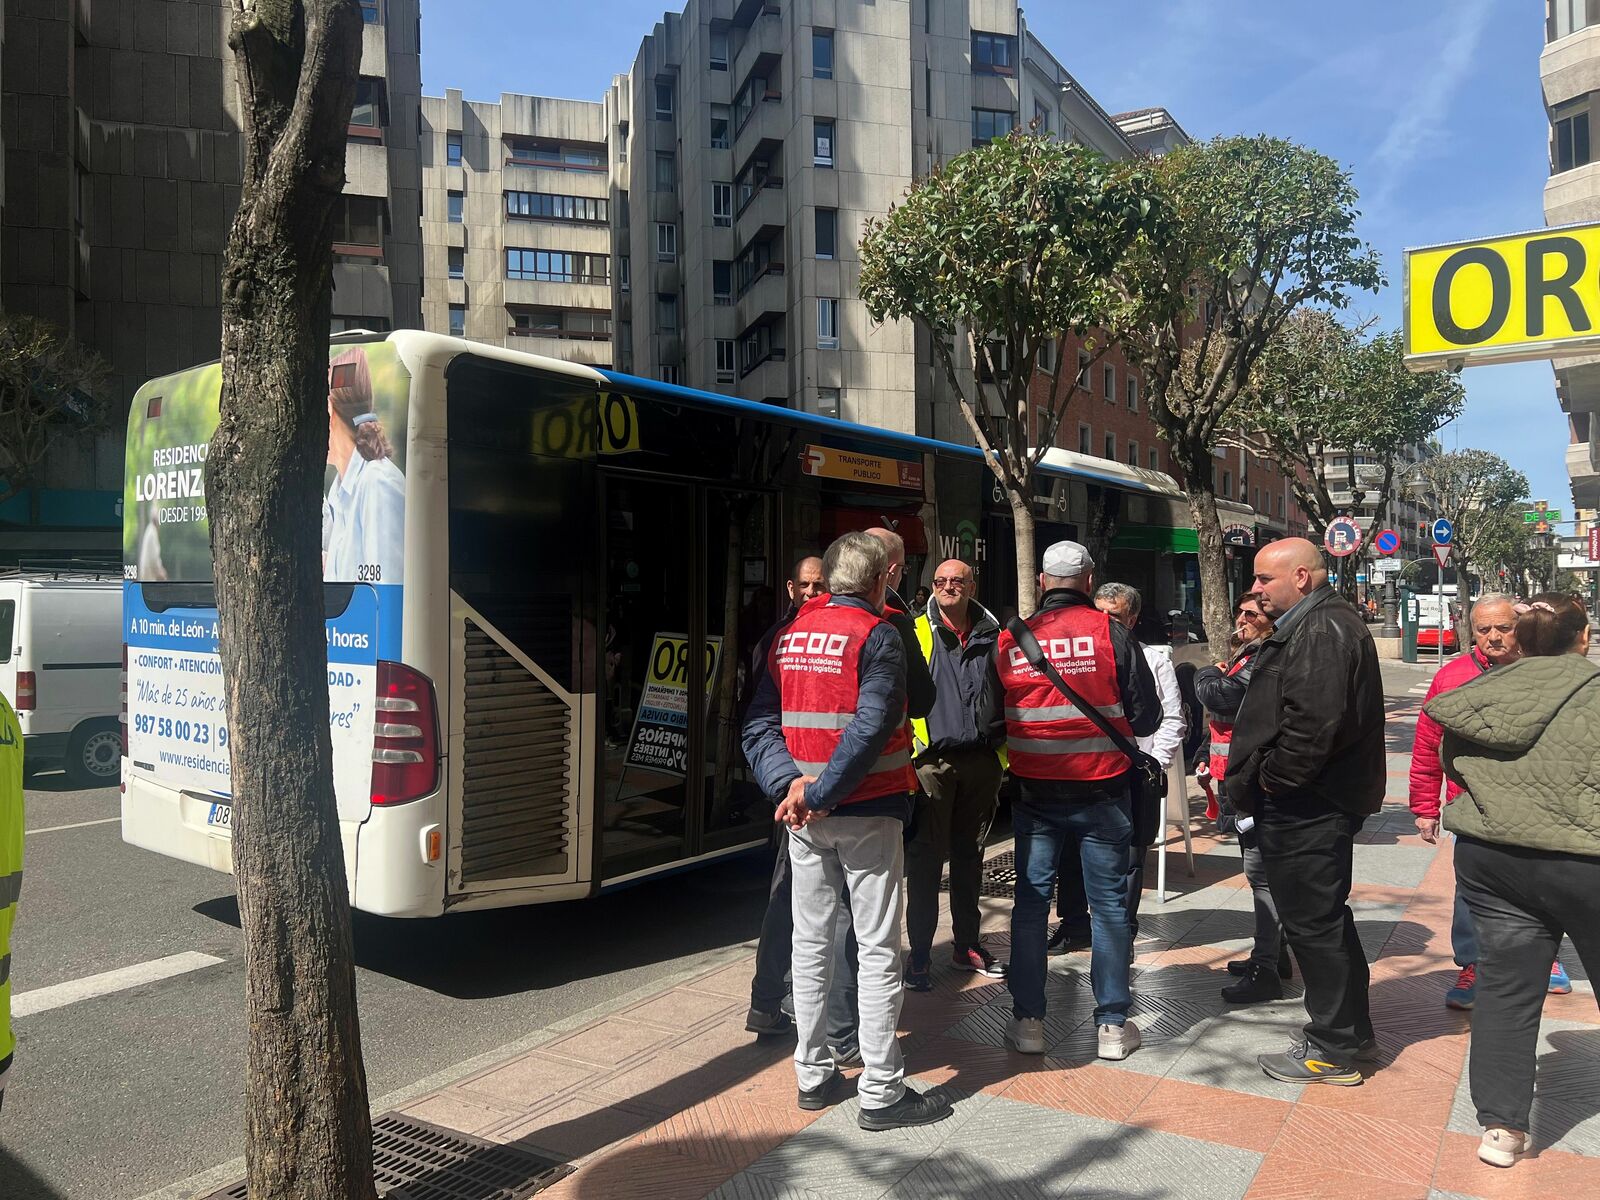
xmin=768 ymin=595 xmax=917 ymax=805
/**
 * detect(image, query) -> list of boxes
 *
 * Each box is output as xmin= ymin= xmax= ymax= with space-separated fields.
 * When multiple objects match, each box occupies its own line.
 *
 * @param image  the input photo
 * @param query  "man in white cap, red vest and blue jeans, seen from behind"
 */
xmin=984 ymin=541 xmax=1162 ymax=1061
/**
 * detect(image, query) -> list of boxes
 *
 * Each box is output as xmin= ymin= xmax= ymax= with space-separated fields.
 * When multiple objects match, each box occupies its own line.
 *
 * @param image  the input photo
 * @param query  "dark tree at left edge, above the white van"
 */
xmin=0 ymin=312 xmax=112 ymax=504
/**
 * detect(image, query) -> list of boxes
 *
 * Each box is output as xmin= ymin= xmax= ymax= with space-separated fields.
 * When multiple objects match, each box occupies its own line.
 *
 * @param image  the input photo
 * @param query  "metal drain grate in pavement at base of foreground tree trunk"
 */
xmin=205 ymin=1112 xmax=570 ymax=1200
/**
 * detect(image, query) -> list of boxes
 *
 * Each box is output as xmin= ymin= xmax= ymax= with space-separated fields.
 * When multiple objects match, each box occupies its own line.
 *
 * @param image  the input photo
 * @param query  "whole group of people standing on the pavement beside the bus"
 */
xmin=742 ymin=530 xmax=1600 ymax=1166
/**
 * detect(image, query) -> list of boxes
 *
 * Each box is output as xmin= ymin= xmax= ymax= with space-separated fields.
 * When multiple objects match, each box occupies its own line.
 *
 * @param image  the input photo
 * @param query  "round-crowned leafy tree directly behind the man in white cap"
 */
xmin=861 ymin=133 xmax=1166 ymax=616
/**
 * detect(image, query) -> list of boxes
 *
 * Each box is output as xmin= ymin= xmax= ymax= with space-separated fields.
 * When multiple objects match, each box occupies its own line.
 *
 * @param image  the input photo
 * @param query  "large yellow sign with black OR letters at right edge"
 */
xmin=1405 ymin=224 xmax=1600 ymax=371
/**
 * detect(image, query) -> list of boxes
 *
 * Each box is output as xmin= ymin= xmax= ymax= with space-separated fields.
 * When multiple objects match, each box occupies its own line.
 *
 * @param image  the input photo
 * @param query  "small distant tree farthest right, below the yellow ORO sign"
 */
xmin=1408 ymin=450 xmax=1528 ymax=592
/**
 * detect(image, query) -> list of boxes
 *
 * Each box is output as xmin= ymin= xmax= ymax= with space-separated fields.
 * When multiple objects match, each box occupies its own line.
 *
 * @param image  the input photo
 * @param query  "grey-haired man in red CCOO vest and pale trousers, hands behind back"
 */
xmin=744 ymin=533 xmax=950 ymax=1130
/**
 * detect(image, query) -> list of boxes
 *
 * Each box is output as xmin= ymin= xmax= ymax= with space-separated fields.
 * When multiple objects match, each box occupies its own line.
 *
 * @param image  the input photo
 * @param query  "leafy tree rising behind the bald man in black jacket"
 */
xmin=1120 ymin=136 xmax=1384 ymax=645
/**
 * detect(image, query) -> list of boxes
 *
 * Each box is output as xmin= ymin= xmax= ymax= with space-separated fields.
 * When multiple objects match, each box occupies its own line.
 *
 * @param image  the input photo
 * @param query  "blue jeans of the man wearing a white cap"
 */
xmin=1006 ymin=778 xmax=1133 ymax=1026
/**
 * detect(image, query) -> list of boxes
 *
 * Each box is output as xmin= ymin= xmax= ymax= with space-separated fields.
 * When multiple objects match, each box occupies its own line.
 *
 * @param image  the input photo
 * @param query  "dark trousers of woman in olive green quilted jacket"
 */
xmin=1456 ymin=838 xmax=1600 ymax=1133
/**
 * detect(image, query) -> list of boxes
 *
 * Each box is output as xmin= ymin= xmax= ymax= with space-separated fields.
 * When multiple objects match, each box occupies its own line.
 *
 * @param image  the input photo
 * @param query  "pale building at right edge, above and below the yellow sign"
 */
xmin=1539 ymin=0 xmax=1600 ymax=509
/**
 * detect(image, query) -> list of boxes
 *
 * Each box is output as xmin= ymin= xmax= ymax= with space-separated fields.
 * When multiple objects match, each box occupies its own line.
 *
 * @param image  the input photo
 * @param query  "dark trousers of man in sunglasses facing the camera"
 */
xmin=906 ymin=746 xmax=1000 ymax=958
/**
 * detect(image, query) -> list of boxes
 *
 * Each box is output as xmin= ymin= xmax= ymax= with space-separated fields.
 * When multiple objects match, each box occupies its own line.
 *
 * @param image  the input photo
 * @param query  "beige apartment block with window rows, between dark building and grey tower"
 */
xmin=421 ymin=88 xmax=616 ymax=366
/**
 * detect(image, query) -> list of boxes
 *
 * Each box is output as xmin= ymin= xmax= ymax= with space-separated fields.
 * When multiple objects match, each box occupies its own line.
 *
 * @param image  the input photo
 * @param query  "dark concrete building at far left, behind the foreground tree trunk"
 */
xmin=0 ymin=0 xmax=421 ymax=563
